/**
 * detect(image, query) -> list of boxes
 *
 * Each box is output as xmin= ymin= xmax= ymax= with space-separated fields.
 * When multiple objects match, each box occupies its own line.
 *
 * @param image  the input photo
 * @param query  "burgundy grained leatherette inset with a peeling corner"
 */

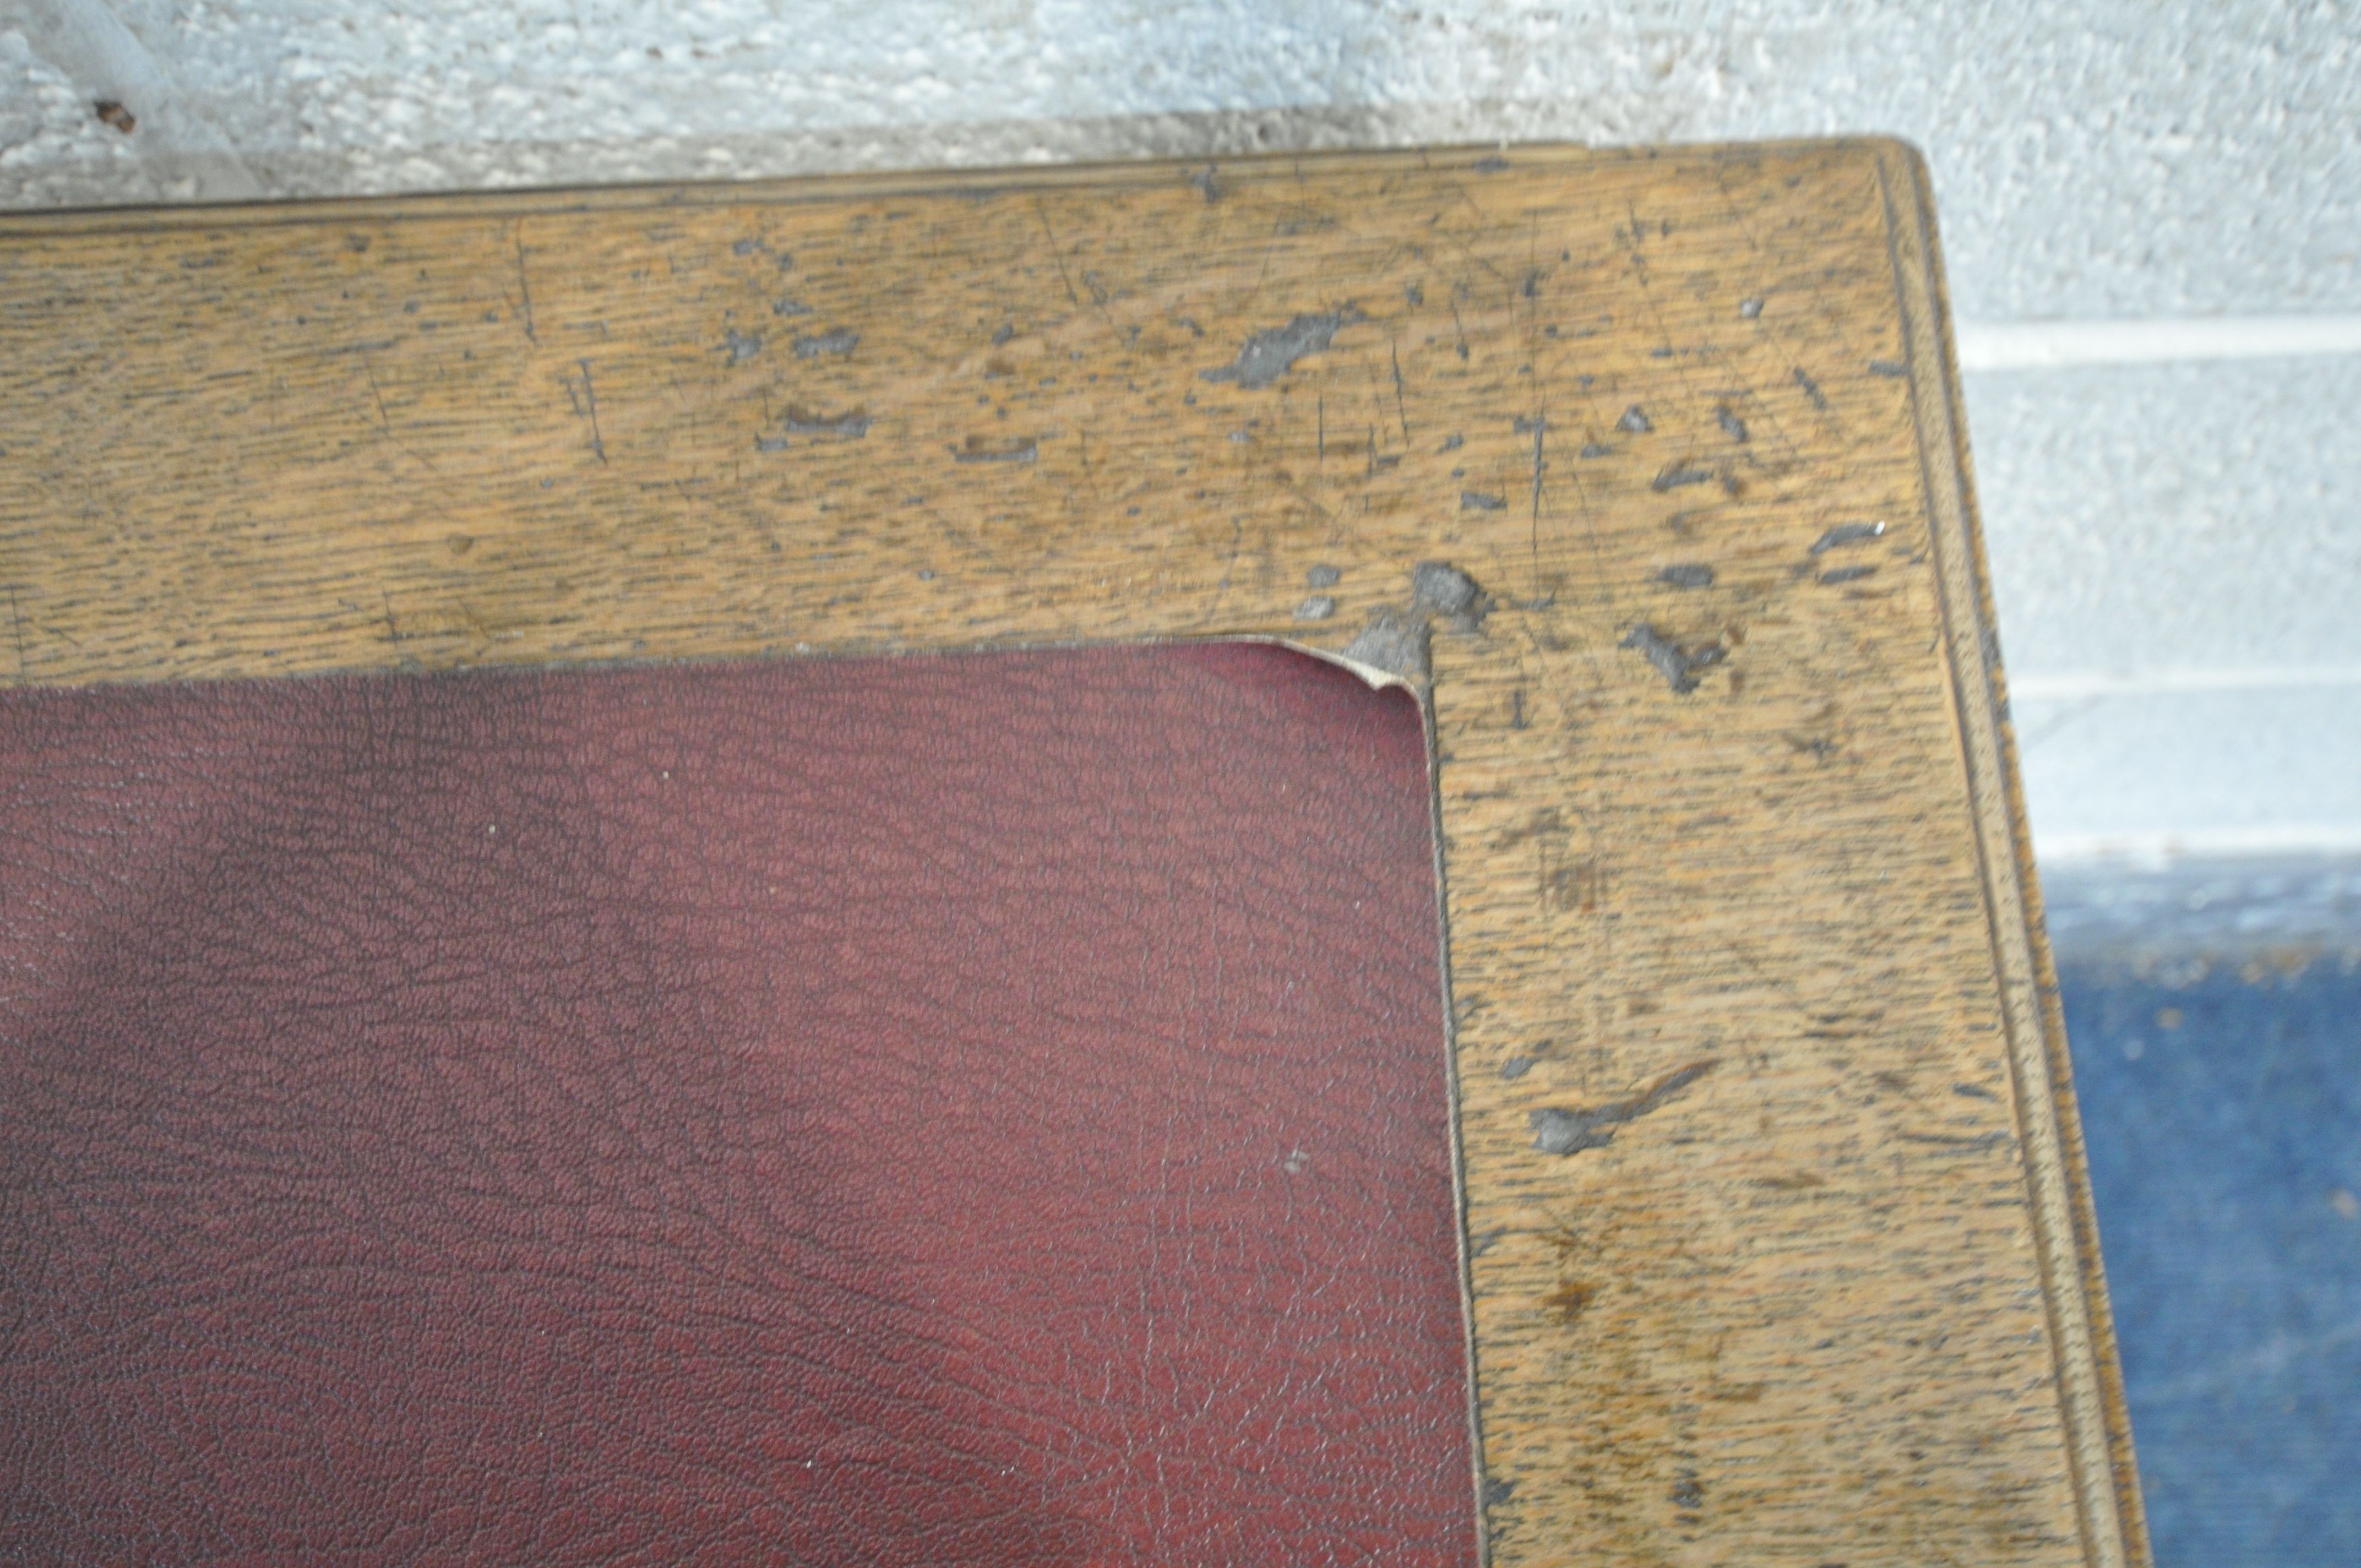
xmin=0 ymin=645 xmax=1476 ymax=1568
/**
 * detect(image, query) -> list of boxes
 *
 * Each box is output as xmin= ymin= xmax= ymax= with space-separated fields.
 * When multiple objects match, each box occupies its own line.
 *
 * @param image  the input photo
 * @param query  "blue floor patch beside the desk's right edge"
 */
xmin=2061 ymin=961 xmax=2361 ymax=1568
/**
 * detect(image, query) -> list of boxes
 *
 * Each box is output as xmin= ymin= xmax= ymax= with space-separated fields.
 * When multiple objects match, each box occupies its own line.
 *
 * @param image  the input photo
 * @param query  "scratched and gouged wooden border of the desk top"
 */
xmin=0 ymin=141 xmax=2146 ymax=1568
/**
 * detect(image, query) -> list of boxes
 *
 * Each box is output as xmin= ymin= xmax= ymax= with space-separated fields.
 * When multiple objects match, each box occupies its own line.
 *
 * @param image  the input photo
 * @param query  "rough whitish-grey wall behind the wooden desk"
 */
xmin=0 ymin=0 xmax=2361 ymax=862
